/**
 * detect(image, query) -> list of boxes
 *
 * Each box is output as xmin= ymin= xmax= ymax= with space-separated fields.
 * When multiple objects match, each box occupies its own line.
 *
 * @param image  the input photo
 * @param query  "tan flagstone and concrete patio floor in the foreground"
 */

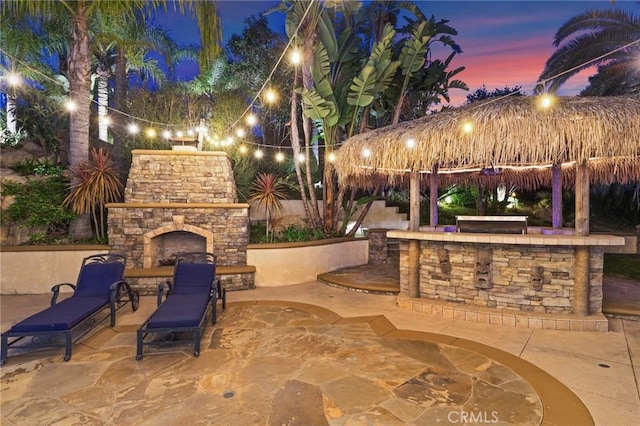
xmin=0 ymin=282 xmax=640 ymax=425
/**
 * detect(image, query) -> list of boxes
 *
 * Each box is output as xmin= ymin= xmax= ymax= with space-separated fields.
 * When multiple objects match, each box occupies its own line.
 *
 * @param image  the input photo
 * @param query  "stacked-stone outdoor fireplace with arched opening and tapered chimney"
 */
xmin=107 ymin=150 xmax=254 ymax=292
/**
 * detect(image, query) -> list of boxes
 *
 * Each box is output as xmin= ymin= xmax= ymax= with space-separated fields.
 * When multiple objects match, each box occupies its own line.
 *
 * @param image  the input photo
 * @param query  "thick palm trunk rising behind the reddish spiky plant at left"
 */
xmin=69 ymin=5 xmax=93 ymax=240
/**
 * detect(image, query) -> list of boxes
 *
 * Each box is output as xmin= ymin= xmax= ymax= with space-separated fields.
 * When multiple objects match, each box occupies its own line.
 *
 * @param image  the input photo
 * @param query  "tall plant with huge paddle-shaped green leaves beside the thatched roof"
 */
xmin=292 ymin=2 xmax=467 ymax=233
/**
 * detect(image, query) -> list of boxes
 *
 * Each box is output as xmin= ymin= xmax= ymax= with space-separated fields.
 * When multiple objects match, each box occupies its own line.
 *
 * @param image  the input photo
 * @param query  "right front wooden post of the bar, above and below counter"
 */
xmin=573 ymin=161 xmax=591 ymax=315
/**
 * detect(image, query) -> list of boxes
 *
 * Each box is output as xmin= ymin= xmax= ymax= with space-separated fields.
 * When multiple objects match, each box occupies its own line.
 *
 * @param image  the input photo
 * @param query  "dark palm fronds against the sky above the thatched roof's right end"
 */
xmin=536 ymin=10 xmax=640 ymax=95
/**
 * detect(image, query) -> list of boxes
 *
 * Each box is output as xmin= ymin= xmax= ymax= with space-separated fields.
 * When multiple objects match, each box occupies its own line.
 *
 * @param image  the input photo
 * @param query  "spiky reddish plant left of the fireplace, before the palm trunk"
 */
xmin=63 ymin=148 xmax=123 ymax=240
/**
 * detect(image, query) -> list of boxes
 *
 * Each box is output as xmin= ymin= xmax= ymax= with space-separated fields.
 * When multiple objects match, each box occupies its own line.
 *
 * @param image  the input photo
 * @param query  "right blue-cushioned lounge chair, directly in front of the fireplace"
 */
xmin=136 ymin=252 xmax=226 ymax=360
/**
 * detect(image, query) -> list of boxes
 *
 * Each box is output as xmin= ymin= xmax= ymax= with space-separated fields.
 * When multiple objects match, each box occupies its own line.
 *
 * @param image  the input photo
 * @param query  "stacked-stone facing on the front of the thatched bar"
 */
xmin=400 ymin=241 xmax=604 ymax=314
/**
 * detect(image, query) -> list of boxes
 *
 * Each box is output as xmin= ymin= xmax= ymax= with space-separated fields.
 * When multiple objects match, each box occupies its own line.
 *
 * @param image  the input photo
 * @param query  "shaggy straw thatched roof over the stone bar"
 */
xmin=335 ymin=96 xmax=640 ymax=189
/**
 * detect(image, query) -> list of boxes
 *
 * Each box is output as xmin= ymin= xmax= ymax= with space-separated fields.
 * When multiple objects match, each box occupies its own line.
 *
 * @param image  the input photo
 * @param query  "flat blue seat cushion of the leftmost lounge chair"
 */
xmin=11 ymin=296 xmax=109 ymax=333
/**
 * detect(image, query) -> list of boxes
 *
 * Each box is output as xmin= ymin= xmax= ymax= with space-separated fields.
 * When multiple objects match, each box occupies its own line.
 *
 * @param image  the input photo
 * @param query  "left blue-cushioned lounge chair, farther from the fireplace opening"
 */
xmin=0 ymin=254 xmax=140 ymax=364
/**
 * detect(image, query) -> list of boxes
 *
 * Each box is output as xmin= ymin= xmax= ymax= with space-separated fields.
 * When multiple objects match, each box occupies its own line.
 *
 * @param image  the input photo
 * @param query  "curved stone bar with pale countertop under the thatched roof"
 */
xmin=387 ymin=230 xmax=625 ymax=331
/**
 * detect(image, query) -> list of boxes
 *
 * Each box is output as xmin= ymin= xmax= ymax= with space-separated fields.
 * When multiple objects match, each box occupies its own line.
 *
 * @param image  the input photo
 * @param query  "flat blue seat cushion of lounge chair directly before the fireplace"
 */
xmin=147 ymin=294 xmax=209 ymax=328
